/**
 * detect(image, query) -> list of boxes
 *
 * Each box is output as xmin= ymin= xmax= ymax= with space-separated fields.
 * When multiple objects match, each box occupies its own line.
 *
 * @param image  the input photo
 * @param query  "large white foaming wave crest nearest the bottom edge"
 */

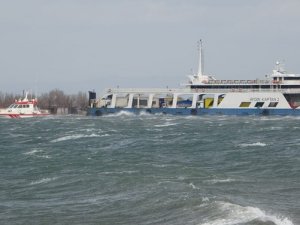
xmin=199 ymin=201 xmax=294 ymax=225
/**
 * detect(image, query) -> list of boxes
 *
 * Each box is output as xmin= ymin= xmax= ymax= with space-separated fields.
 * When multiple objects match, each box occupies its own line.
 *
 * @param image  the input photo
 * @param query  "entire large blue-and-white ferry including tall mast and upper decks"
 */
xmin=87 ymin=41 xmax=300 ymax=116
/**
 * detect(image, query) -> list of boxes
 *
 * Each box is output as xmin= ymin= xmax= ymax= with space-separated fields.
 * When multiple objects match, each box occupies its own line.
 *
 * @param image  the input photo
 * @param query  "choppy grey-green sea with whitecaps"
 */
xmin=0 ymin=113 xmax=300 ymax=225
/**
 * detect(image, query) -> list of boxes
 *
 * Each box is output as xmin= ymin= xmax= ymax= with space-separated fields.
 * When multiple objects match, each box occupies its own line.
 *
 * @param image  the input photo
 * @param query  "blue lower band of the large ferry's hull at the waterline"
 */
xmin=87 ymin=108 xmax=300 ymax=116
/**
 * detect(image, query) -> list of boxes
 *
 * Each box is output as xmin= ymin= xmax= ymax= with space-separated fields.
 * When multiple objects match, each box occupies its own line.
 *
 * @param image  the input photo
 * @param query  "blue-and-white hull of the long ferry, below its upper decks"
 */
xmin=87 ymin=90 xmax=300 ymax=116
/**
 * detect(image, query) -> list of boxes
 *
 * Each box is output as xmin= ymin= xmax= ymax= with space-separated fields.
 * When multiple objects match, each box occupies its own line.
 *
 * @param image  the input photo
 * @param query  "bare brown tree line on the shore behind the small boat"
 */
xmin=0 ymin=89 xmax=88 ymax=110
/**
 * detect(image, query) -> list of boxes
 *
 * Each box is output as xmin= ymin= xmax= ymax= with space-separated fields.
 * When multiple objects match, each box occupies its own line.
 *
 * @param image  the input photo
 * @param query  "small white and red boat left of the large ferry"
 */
xmin=0 ymin=92 xmax=50 ymax=118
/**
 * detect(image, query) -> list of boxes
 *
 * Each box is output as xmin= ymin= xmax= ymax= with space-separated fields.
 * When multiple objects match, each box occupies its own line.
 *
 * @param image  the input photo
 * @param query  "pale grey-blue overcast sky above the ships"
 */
xmin=0 ymin=0 xmax=300 ymax=93
